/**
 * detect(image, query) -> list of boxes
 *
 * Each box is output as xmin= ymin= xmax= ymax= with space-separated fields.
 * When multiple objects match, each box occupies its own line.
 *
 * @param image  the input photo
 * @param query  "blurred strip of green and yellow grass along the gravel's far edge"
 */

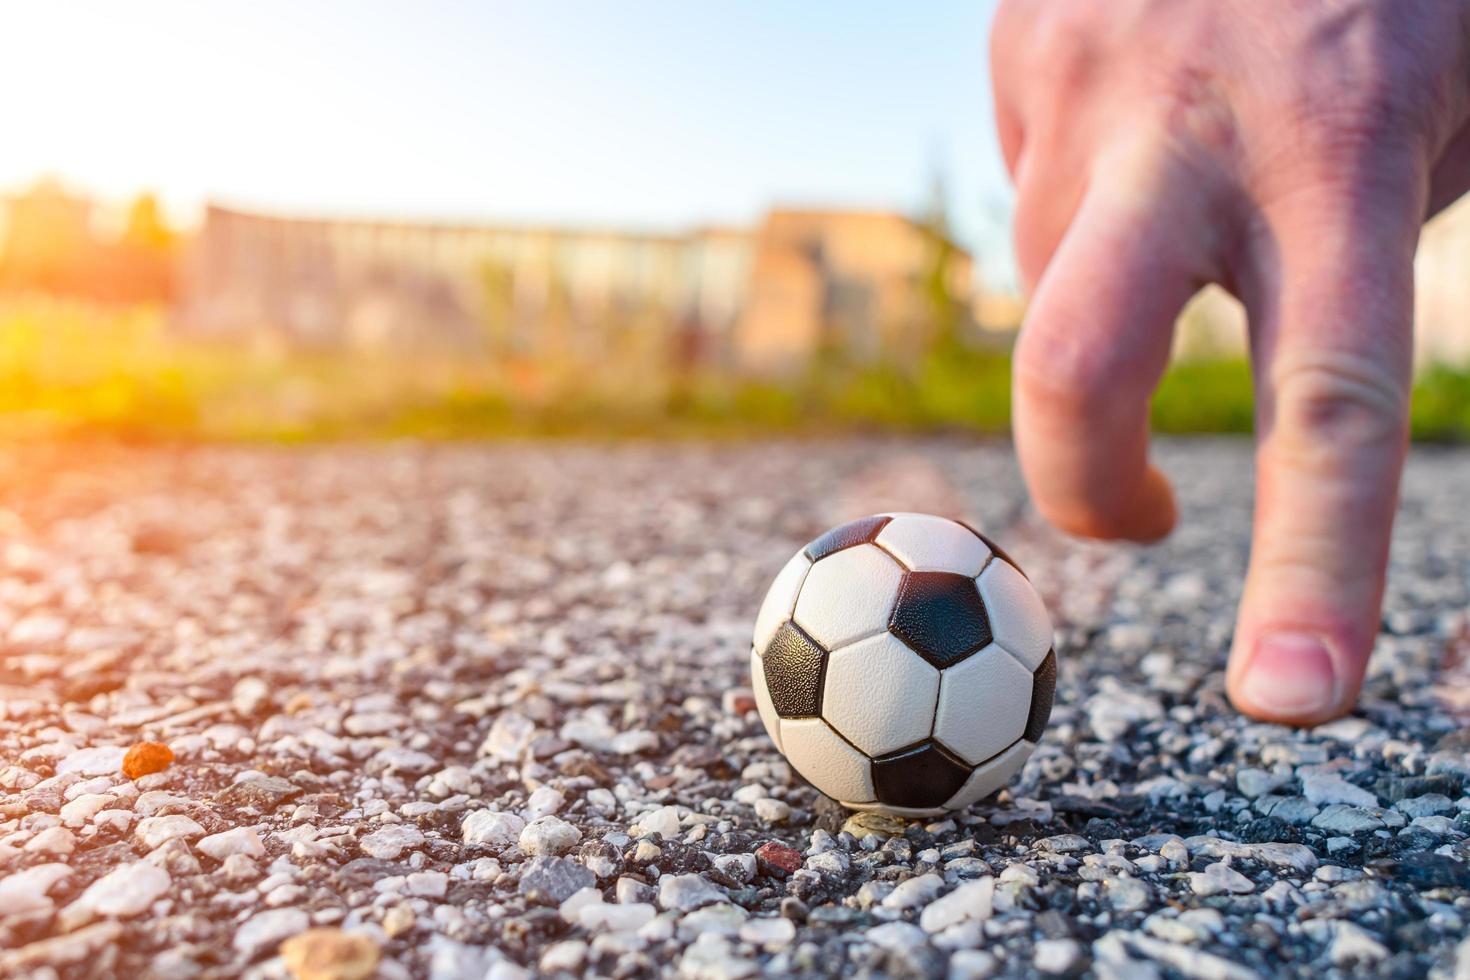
xmin=0 ymin=300 xmax=1470 ymax=442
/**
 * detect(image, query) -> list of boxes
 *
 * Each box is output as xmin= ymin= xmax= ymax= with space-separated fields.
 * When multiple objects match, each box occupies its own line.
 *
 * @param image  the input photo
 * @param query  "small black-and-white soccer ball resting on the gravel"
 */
xmin=751 ymin=514 xmax=1057 ymax=817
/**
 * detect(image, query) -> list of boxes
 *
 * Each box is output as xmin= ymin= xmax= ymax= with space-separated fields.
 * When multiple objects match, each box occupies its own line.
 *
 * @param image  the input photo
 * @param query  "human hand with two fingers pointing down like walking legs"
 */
xmin=991 ymin=0 xmax=1470 ymax=724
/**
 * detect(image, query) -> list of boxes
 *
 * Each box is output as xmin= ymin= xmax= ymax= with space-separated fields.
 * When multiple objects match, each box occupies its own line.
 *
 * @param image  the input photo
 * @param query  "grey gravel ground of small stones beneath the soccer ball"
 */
xmin=0 ymin=442 xmax=1470 ymax=980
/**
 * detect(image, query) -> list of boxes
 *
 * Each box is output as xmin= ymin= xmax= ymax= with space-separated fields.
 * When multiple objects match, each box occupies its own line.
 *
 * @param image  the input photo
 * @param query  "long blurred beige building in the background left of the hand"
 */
xmin=178 ymin=207 xmax=972 ymax=372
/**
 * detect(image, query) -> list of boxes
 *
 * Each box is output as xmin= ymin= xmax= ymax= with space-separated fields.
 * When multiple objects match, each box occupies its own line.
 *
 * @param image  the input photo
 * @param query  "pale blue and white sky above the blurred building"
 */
xmin=0 ymin=0 xmax=1010 ymax=283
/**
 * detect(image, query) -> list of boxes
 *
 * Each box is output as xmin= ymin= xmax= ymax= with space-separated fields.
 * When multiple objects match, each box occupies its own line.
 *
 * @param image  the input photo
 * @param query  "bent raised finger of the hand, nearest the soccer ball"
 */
xmin=1011 ymin=143 xmax=1208 ymax=541
